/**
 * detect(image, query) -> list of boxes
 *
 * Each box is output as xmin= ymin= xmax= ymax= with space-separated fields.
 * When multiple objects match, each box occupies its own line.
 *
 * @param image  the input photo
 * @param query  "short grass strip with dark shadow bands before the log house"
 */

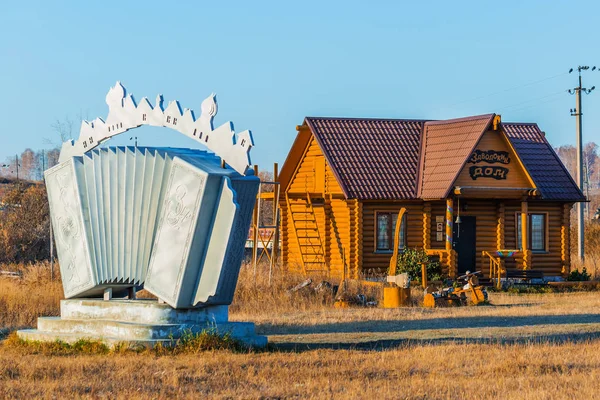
xmin=254 ymin=292 xmax=600 ymax=349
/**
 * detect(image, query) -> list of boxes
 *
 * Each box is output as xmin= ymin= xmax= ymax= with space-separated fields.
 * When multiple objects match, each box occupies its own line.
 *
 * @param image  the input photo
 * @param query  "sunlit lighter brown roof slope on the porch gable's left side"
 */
xmin=417 ymin=114 xmax=495 ymax=199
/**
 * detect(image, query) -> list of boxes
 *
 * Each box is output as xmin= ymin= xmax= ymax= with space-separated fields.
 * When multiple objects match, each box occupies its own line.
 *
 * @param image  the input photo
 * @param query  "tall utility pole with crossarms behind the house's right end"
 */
xmin=569 ymin=65 xmax=596 ymax=262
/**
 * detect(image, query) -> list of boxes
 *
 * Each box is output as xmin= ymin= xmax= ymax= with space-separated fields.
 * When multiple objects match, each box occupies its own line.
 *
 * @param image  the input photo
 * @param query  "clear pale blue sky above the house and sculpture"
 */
xmin=0 ymin=0 xmax=600 ymax=169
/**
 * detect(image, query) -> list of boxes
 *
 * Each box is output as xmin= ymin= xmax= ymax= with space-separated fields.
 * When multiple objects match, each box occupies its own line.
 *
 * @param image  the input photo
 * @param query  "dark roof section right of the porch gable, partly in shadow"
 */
xmin=502 ymin=123 xmax=585 ymax=201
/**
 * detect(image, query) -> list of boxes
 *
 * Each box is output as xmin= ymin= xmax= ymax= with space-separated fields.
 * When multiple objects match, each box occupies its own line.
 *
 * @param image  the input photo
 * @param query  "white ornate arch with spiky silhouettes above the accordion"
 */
xmin=59 ymin=81 xmax=254 ymax=174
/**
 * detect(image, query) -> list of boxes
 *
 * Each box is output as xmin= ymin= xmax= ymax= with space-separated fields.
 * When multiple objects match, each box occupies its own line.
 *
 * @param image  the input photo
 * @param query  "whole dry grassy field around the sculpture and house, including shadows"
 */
xmin=0 ymin=266 xmax=600 ymax=399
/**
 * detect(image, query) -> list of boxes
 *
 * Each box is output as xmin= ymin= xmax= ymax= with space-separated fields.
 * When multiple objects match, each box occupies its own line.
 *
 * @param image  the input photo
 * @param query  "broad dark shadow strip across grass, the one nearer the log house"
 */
xmin=257 ymin=314 xmax=600 ymax=335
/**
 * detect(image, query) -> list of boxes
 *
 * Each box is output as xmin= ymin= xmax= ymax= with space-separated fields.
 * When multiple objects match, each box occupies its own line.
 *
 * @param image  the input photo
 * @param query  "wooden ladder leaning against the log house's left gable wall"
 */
xmin=286 ymin=193 xmax=329 ymax=275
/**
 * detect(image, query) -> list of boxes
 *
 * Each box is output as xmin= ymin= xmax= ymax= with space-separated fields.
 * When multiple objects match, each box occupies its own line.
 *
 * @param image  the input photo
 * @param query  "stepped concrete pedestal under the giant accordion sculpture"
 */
xmin=17 ymin=299 xmax=267 ymax=347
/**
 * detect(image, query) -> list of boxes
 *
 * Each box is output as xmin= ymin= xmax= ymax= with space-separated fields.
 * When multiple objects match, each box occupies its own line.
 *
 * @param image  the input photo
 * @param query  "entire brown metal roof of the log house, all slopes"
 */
xmin=281 ymin=114 xmax=585 ymax=202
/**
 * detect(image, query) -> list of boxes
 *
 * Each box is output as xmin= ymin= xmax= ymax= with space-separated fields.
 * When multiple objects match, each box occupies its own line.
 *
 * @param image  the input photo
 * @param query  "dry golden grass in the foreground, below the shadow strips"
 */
xmin=0 ymin=341 xmax=600 ymax=399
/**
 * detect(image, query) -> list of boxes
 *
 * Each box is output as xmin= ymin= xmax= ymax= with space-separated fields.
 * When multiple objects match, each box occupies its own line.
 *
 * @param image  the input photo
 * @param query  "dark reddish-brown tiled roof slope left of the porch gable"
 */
xmin=306 ymin=117 xmax=425 ymax=200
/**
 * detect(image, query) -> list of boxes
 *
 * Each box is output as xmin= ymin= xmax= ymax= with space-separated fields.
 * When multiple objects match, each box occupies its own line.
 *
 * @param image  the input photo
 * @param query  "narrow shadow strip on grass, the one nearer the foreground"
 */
xmin=269 ymin=332 xmax=600 ymax=352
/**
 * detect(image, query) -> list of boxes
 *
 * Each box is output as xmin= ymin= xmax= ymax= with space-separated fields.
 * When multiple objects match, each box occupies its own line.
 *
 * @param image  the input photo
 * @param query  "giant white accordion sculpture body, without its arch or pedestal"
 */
xmin=45 ymin=147 xmax=259 ymax=308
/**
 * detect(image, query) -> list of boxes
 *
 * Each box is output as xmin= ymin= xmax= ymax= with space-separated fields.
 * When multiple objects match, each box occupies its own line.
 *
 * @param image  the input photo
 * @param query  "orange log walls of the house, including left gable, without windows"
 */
xmin=280 ymin=131 xmax=571 ymax=278
